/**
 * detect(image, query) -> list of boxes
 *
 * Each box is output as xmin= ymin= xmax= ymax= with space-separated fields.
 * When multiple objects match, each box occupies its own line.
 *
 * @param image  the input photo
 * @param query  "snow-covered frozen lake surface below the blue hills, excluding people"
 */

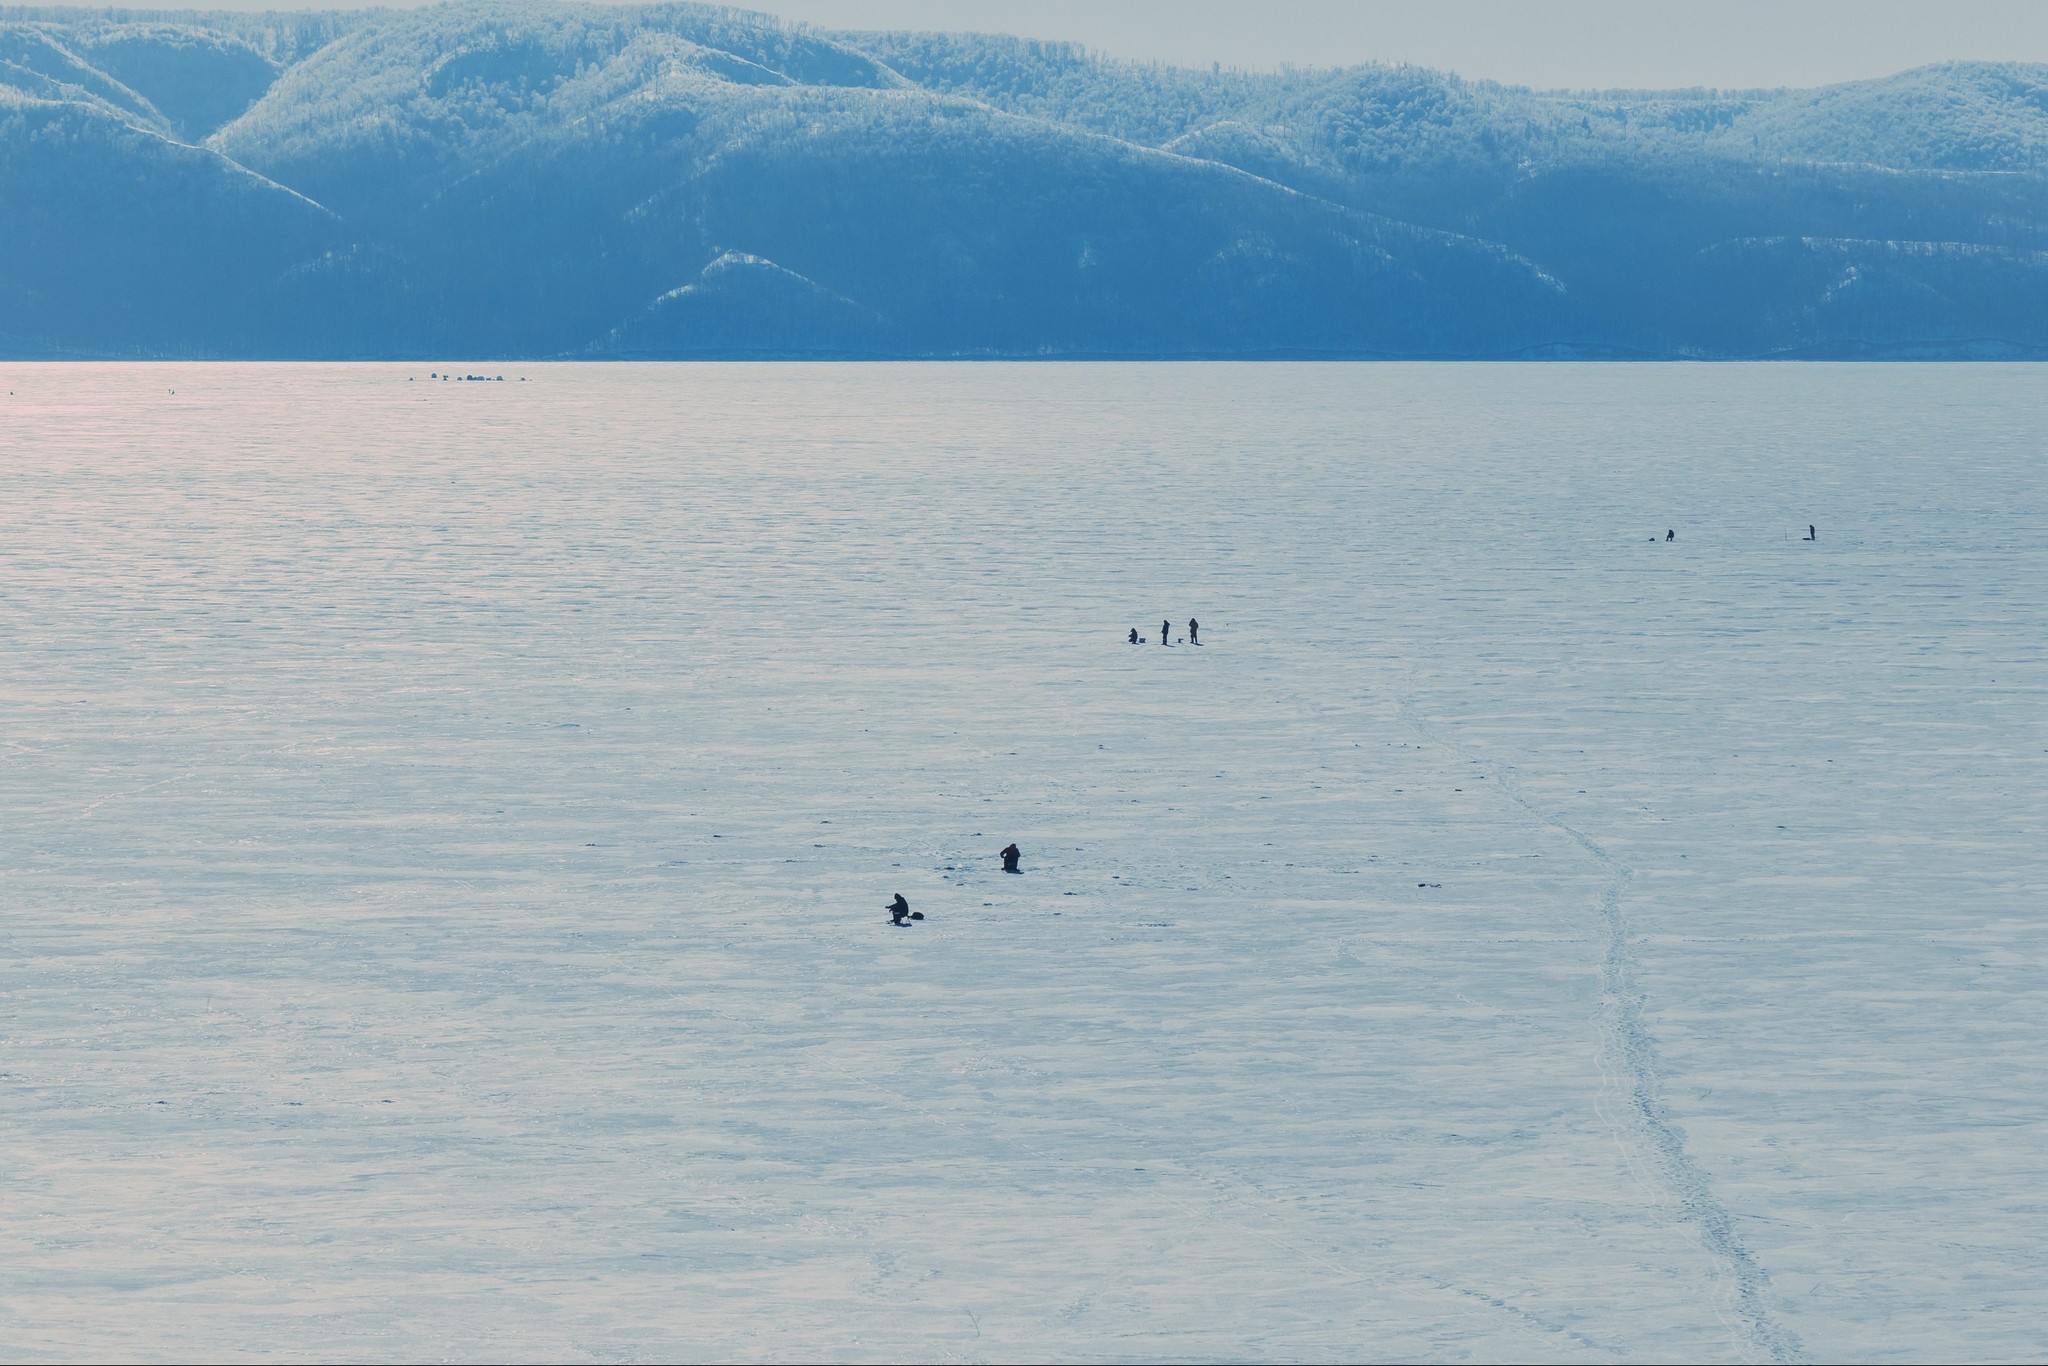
xmin=0 ymin=367 xmax=2048 ymax=1362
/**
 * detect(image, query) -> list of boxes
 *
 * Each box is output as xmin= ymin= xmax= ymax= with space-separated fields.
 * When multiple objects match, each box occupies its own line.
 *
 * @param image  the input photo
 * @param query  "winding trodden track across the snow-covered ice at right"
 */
xmin=1399 ymin=698 xmax=1804 ymax=1362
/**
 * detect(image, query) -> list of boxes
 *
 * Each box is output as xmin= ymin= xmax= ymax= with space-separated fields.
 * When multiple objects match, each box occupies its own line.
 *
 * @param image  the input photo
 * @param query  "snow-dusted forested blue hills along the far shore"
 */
xmin=0 ymin=0 xmax=2048 ymax=358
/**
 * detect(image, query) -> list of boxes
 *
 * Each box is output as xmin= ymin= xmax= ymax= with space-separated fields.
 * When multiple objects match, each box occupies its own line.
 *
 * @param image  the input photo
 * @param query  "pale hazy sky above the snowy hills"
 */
xmin=184 ymin=0 xmax=2048 ymax=86
